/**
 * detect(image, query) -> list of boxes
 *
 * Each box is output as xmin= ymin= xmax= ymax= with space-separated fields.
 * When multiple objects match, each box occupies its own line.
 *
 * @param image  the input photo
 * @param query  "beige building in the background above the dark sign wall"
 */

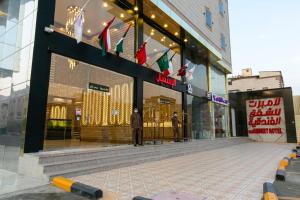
xmin=228 ymin=68 xmax=284 ymax=92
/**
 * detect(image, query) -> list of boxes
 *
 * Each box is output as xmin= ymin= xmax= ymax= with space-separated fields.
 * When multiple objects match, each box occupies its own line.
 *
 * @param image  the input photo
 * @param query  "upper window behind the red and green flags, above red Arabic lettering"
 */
xmin=144 ymin=23 xmax=181 ymax=80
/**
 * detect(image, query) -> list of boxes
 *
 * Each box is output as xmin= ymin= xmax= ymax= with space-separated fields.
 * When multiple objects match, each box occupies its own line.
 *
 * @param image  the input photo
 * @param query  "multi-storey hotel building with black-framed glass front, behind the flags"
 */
xmin=0 ymin=0 xmax=231 ymax=171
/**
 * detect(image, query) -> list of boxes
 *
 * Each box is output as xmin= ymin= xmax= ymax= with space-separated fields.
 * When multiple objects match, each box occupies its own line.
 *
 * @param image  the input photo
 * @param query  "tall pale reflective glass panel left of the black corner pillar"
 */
xmin=0 ymin=0 xmax=37 ymax=172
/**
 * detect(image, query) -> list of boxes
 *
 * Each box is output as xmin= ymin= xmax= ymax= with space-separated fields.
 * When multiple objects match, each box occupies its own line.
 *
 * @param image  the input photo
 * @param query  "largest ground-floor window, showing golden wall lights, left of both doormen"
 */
xmin=45 ymin=54 xmax=133 ymax=149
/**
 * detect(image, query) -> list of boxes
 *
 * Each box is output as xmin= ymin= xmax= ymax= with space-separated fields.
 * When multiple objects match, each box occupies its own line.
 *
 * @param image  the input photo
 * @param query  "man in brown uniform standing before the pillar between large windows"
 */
xmin=130 ymin=108 xmax=143 ymax=147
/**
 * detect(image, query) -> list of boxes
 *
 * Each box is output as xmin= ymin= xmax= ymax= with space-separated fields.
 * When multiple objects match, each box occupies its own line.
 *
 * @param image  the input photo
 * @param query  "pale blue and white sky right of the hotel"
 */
xmin=229 ymin=0 xmax=300 ymax=95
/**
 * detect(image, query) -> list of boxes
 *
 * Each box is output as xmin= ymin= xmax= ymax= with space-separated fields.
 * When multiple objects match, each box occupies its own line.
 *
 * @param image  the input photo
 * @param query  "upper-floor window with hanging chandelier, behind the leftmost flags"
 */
xmin=54 ymin=0 xmax=135 ymax=62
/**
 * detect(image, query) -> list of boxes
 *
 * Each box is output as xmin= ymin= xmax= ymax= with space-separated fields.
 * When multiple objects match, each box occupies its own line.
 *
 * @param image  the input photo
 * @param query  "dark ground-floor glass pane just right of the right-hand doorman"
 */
xmin=187 ymin=95 xmax=212 ymax=139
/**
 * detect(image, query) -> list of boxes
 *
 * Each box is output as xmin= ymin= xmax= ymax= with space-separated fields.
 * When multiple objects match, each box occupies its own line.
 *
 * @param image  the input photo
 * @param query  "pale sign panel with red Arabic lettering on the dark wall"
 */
xmin=246 ymin=97 xmax=286 ymax=142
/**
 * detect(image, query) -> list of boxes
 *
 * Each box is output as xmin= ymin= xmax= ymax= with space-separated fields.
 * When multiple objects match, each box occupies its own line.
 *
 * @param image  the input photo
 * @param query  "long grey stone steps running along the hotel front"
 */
xmin=20 ymin=138 xmax=250 ymax=180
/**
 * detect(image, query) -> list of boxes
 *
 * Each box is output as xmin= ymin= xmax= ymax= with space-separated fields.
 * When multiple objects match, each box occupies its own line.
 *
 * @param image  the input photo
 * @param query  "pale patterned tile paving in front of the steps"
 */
xmin=74 ymin=143 xmax=292 ymax=200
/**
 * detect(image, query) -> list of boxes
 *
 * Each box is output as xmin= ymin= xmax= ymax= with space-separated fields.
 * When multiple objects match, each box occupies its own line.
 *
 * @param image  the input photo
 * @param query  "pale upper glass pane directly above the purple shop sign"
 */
xmin=211 ymin=67 xmax=226 ymax=97
